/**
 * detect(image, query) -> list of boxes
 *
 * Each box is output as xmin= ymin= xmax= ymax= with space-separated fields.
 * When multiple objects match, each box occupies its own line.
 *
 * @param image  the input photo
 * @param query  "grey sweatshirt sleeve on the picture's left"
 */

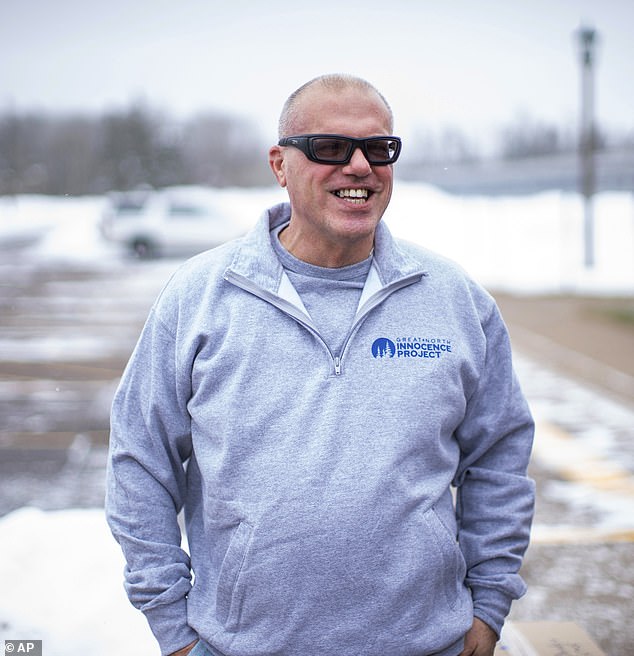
xmin=106 ymin=311 xmax=196 ymax=654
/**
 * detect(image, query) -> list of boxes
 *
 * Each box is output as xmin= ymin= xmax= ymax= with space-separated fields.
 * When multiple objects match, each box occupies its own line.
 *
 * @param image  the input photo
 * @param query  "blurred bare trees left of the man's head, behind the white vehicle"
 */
xmin=0 ymin=103 xmax=271 ymax=195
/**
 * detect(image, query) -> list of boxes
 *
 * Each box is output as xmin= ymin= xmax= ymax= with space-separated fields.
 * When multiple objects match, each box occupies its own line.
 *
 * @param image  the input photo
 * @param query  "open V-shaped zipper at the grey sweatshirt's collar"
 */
xmin=224 ymin=271 xmax=423 ymax=376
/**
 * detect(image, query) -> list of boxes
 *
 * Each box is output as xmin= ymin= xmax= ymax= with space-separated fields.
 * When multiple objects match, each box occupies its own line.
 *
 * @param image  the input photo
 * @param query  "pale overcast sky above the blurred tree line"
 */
xmin=0 ymin=0 xmax=634 ymax=150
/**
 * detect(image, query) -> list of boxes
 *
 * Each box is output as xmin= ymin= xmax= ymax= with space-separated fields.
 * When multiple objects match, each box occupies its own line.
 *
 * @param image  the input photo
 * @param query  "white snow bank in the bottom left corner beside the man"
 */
xmin=0 ymin=508 xmax=158 ymax=656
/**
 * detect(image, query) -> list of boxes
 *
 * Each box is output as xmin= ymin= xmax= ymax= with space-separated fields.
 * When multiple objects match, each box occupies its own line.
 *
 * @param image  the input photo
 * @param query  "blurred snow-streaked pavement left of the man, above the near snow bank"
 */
xmin=0 ymin=250 xmax=175 ymax=515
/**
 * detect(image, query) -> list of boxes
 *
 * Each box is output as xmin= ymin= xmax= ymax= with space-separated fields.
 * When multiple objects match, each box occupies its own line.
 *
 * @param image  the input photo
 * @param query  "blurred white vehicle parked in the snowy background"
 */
xmin=100 ymin=188 xmax=244 ymax=258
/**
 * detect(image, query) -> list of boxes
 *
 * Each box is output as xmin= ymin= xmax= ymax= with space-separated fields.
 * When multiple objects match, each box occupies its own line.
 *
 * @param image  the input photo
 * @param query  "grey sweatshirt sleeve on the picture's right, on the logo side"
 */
xmin=455 ymin=300 xmax=535 ymax=635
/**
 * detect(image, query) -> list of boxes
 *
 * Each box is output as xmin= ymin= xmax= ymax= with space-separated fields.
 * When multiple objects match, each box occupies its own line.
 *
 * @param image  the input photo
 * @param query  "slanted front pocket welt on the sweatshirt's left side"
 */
xmin=216 ymin=522 xmax=253 ymax=630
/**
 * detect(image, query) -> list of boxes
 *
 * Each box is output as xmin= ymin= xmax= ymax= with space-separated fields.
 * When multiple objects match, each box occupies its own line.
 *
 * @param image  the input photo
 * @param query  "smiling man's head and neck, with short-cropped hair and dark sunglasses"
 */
xmin=270 ymin=80 xmax=400 ymax=268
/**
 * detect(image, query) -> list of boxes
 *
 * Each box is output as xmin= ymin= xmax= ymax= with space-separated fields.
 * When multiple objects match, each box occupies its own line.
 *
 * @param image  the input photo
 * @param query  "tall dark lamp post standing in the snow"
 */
xmin=577 ymin=27 xmax=597 ymax=268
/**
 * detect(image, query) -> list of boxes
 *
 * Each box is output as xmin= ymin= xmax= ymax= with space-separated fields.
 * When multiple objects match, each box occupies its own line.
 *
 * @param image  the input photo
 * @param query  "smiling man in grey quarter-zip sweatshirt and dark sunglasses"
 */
xmin=107 ymin=76 xmax=534 ymax=656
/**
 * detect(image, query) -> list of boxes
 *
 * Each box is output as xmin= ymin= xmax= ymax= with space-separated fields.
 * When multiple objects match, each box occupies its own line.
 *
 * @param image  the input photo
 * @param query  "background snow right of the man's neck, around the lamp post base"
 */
xmin=386 ymin=185 xmax=634 ymax=294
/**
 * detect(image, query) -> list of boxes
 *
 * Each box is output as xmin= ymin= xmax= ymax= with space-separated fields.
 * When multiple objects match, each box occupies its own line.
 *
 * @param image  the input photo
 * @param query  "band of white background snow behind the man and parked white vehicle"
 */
xmin=0 ymin=182 xmax=634 ymax=295
